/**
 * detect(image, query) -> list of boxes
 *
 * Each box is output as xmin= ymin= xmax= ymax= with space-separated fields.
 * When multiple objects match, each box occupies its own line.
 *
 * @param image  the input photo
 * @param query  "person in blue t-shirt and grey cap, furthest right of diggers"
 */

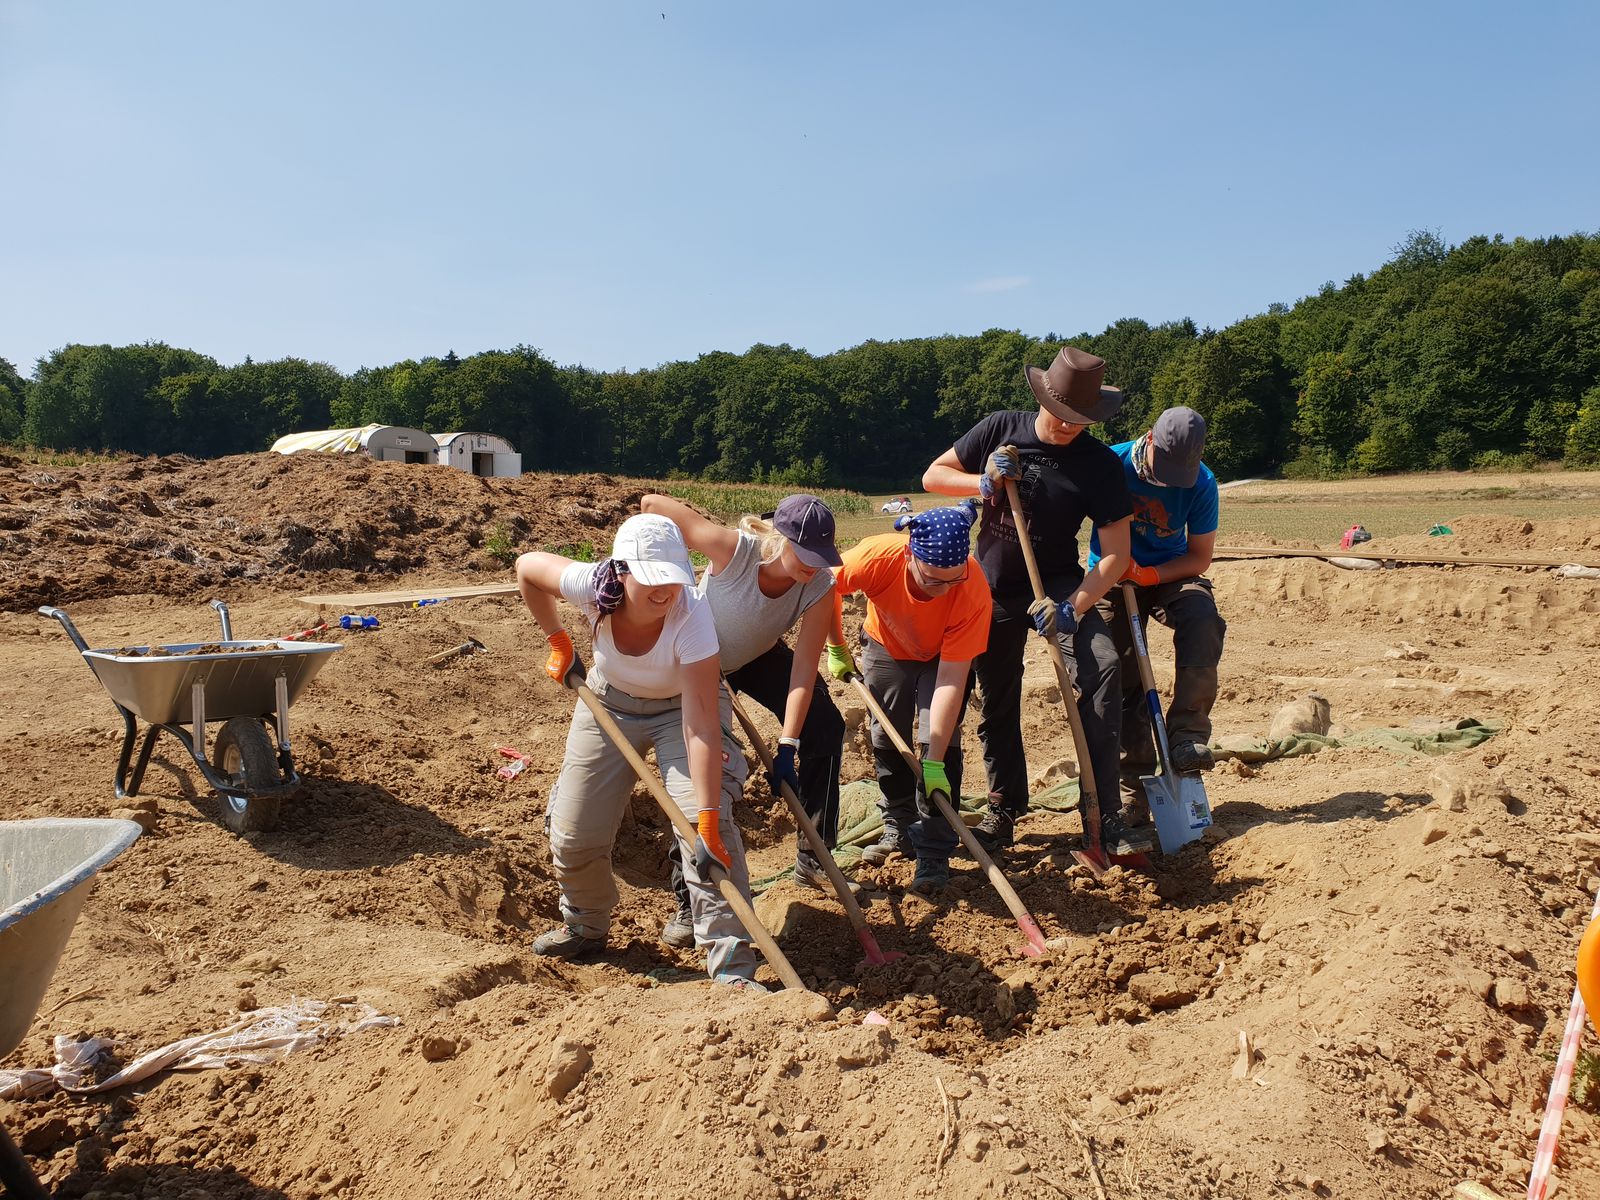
xmin=1090 ymin=408 xmax=1227 ymax=811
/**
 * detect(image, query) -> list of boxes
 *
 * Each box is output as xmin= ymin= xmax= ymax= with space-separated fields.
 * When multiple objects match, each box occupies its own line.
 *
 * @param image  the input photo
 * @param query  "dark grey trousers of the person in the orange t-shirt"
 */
xmin=861 ymin=637 xmax=973 ymax=859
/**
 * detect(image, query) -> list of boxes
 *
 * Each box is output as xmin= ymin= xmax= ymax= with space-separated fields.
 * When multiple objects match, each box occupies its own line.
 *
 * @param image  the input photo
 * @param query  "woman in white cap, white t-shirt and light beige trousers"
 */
xmin=517 ymin=514 xmax=757 ymax=987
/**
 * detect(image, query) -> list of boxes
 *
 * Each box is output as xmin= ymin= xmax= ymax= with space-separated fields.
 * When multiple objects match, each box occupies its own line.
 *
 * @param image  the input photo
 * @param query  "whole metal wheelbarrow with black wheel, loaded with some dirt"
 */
xmin=38 ymin=600 xmax=344 ymax=834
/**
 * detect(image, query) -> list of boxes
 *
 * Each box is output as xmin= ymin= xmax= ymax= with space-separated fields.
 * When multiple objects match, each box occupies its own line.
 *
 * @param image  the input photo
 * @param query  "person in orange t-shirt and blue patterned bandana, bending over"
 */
xmin=827 ymin=504 xmax=992 ymax=894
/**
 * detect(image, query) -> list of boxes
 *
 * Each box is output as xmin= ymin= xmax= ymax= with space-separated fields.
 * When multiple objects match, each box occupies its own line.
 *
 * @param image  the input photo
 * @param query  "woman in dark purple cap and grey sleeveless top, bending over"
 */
xmin=638 ymin=494 xmax=845 ymax=946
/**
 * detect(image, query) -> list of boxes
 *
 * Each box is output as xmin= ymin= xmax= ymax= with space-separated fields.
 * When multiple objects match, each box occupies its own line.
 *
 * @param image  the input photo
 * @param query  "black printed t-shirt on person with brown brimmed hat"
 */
xmin=955 ymin=413 xmax=1133 ymax=595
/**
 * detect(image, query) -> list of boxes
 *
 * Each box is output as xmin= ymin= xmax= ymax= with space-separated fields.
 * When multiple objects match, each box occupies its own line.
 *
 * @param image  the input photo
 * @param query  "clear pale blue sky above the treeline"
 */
xmin=0 ymin=0 xmax=1600 ymax=374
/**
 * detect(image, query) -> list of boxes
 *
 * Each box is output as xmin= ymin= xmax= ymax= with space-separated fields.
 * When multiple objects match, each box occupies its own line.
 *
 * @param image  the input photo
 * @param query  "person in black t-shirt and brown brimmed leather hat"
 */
xmin=922 ymin=346 xmax=1152 ymax=854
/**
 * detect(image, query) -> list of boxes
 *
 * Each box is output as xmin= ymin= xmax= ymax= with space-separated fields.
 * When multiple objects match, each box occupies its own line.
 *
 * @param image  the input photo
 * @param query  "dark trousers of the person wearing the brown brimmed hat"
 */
xmin=974 ymin=576 xmax=1122 ymax=816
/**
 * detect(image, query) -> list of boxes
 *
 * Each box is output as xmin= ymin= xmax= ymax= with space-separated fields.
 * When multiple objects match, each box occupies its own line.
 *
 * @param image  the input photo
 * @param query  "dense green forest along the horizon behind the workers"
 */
xmin=0 ymin=232 xmax=1600 ymax=488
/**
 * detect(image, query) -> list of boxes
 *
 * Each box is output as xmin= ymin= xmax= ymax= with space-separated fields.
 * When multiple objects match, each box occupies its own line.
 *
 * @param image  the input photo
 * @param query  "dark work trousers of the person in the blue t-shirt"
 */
xmin=1098 ymin=576 xmax=1227 ymax=795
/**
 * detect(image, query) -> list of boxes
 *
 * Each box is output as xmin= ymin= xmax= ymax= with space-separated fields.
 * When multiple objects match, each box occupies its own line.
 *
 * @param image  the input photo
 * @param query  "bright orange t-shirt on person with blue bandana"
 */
xmin=834 ymin=533 xmax=990 ymax=662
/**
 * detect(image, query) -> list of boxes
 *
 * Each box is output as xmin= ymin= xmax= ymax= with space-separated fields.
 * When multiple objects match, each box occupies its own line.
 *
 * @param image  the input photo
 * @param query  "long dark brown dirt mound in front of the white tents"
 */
xmin=0 ymin=454 xmax=642 ymax=610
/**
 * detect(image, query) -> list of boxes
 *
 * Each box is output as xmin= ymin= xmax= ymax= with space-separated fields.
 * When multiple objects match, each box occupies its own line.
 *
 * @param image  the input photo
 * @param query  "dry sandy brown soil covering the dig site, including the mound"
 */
xmin=0 ymin=456 xmax=1600 ymax=1200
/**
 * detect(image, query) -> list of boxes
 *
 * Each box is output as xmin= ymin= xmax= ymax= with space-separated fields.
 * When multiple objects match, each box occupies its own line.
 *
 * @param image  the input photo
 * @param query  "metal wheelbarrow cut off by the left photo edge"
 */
xmin=0 ymin=818 xmax=139 ymax=1200
